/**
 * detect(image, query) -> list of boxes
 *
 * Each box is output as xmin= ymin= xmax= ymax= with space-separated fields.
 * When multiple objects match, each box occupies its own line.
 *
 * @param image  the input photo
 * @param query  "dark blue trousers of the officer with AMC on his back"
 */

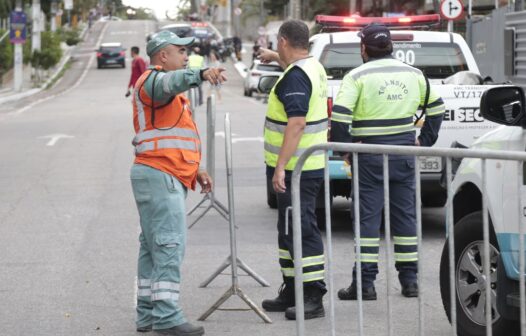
xmin=353 ymin=154 xmax=418 ymax=288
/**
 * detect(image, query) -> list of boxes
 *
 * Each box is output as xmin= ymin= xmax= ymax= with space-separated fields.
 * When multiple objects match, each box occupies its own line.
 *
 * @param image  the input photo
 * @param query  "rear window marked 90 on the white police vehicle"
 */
xmin=320 ymin=42 xmax=468 ymax=79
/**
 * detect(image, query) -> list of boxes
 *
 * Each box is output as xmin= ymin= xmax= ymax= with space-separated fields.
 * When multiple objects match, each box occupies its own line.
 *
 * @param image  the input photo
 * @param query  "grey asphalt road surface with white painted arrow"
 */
xmin=0 ymin=21 xmax=449 ymax=336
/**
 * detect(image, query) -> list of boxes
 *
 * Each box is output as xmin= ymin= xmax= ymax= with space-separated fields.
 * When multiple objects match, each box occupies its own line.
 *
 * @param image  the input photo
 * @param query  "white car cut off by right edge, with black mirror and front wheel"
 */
xmin=440 ymin=86 xmax=526 ymax=336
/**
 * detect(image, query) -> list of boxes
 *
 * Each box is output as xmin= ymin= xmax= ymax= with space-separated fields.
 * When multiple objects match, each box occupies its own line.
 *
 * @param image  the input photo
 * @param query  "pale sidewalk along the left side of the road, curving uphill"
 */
xmin=0 ymin=26 xmax=88 ymax=105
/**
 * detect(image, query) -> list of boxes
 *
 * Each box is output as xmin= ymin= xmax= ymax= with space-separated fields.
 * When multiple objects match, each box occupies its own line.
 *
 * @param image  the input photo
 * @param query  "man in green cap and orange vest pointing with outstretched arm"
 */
xmin=131 ymin=31 xmax=226 ymax=336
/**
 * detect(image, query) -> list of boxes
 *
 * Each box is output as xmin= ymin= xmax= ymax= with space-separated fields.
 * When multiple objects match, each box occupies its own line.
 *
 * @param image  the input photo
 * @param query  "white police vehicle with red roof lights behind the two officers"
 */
xmin=310 ymin=14 xmax=504 ymax=213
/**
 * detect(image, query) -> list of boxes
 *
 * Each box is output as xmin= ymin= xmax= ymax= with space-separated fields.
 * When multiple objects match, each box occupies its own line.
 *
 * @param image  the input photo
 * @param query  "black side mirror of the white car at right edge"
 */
xmin=480 ymin=86 xmax=526 ymax=126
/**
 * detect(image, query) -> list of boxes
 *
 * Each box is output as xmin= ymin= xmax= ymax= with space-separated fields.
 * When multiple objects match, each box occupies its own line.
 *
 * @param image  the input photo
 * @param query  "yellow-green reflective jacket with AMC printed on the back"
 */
xmin=331 ymin=58 xmax=444 ymax=137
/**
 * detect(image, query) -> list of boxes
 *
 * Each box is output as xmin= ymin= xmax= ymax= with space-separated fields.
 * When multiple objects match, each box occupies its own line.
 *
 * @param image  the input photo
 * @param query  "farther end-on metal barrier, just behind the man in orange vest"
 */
xmin=187 ymin=90 xmax=229 ymax=229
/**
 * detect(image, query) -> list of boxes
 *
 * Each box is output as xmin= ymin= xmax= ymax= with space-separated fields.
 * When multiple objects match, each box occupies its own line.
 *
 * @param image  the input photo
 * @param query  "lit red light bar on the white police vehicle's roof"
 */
xmin=315 ymin=14 xmax=440 ymax=31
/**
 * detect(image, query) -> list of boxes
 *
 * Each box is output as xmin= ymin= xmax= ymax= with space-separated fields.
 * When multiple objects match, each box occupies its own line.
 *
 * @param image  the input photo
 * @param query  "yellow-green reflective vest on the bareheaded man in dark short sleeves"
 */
xmin=264 ymin=57 xmax=328 ymax=171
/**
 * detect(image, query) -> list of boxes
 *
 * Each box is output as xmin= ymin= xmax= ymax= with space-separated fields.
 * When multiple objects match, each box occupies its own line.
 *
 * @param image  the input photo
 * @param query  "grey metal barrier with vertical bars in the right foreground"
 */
xmin=292 ymin=143 xmax=526 ymax=336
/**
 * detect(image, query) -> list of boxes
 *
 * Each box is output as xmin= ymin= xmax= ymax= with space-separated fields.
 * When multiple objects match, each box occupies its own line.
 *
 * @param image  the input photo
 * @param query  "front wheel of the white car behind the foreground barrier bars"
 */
xmin=440 ymin=211 xmax=517 ymax=336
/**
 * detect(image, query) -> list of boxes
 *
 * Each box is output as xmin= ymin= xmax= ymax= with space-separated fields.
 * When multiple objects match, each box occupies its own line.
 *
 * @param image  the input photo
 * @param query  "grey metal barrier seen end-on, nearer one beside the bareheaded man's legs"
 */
xmin=199 ymin=113 xmax=272 ymax=323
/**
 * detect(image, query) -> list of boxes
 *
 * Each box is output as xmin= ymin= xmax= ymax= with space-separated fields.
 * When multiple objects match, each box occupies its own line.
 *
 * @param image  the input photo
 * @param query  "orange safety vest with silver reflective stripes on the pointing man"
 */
xmin=132 ymin=69 xmax=201 ymax=189
